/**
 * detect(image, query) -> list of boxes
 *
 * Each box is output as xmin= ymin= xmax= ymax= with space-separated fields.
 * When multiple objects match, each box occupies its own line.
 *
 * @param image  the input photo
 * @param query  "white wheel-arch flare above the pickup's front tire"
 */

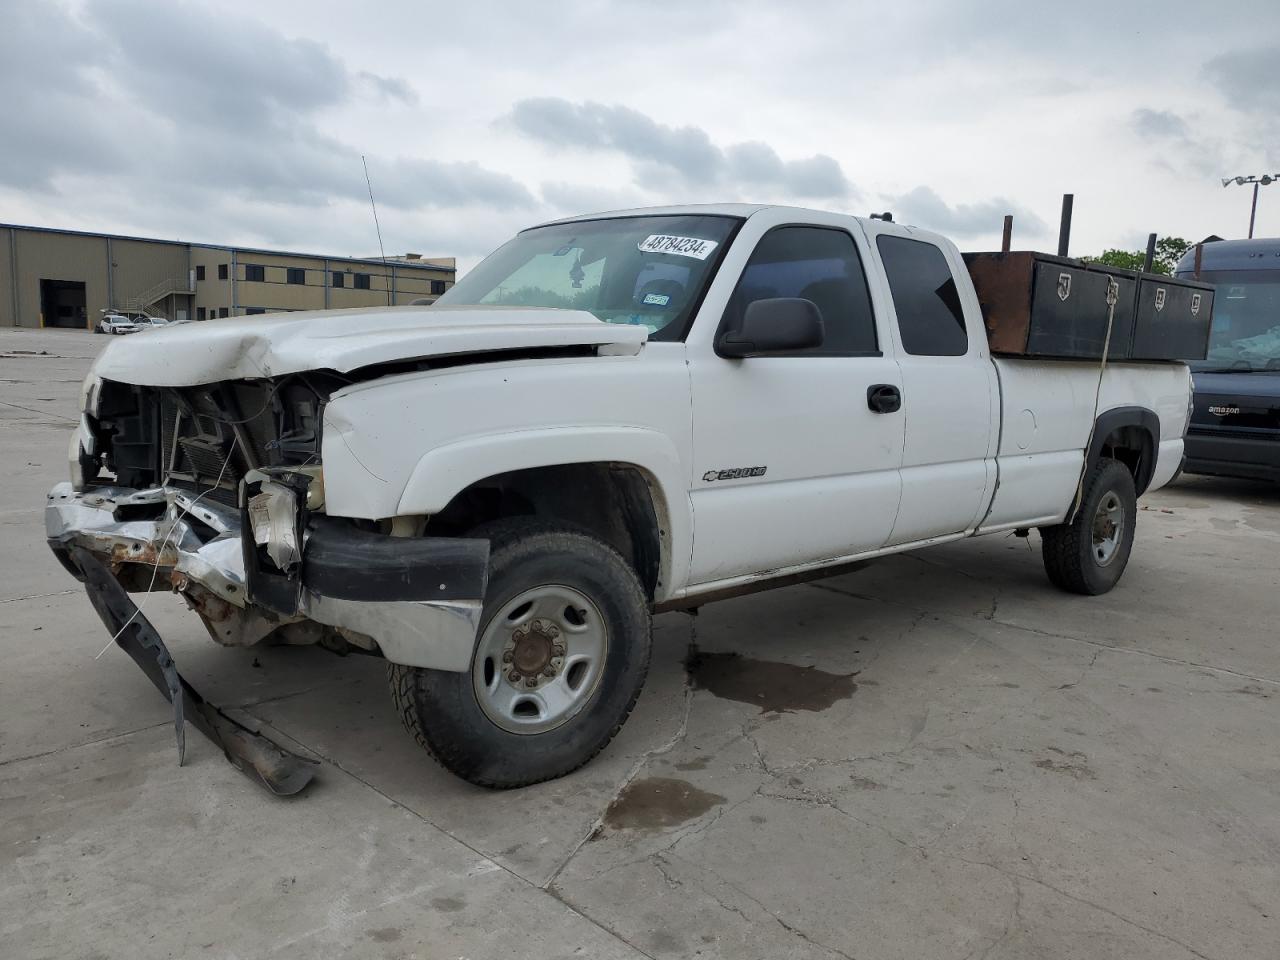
xmin=397 ymin=426 xmax=692 ymax=589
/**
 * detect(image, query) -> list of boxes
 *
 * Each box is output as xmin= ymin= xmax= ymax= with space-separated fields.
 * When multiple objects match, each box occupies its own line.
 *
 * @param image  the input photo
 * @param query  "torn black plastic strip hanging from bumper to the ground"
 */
xmin=70 ymin=545 xmax=319 ymax=796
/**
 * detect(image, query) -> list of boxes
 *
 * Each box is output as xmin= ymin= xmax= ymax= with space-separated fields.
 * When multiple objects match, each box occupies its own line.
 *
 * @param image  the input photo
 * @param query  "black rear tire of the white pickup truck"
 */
xmin=1041 ymin=457 xmax=1138 ymax=596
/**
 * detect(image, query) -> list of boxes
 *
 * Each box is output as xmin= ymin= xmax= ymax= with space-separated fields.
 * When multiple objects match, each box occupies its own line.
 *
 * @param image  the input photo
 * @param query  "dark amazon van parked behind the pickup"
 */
xmin=1176 ymin=238 xmax=1280 ymax=480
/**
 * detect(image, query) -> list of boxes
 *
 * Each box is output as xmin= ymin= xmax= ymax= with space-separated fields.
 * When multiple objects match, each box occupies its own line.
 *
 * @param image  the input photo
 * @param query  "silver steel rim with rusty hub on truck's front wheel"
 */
xmin=471 ymin=584 xmax=609 ymax=733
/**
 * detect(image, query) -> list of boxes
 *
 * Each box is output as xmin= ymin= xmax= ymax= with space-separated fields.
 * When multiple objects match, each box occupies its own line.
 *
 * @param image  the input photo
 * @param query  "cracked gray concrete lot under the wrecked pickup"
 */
xmin=0 ymin=330 xmax=1280 ymax=960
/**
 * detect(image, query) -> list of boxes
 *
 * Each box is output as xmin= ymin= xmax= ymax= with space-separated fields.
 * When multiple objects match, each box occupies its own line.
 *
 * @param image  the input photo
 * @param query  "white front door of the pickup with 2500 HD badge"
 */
xmin=689 ymin=221 xmax=905 ymax=584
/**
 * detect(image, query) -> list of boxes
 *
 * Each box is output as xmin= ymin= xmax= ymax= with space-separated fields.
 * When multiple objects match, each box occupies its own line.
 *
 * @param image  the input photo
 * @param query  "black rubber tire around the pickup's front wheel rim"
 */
xmin=388 ymin=517 xmax=653 ymax=790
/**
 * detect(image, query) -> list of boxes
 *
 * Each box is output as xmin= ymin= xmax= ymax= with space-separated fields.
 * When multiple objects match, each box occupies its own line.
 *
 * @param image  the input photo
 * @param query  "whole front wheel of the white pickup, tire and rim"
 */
xmin=388 ymin=517 xmax=652 ymax=788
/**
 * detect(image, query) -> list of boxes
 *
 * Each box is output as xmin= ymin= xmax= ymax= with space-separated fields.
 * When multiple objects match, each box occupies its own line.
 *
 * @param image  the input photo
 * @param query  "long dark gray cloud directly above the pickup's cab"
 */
xmin=504 ymin=97 xmax=852 ymax=197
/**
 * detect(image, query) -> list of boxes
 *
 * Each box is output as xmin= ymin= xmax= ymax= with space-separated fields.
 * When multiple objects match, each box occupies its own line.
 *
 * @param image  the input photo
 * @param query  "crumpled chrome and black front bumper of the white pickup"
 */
xmin=45 ymin=483 xmax=489 ymax=671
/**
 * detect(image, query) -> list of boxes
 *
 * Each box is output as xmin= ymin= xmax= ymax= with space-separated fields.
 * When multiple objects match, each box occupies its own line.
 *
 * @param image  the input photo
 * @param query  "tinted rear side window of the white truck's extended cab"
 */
xmin=876 ymin=237 xmax=969 ymax=357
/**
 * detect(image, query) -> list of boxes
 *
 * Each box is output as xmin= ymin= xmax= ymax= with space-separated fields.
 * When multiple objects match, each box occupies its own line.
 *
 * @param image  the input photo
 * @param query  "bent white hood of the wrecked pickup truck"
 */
xmin=92 ymin=306 xmax=648 ymax=387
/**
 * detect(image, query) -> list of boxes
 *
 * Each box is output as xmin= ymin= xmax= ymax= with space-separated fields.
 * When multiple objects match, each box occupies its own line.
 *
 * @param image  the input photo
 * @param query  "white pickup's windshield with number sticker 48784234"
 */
xmin=436 ymin=215 xmax=741 ymax=340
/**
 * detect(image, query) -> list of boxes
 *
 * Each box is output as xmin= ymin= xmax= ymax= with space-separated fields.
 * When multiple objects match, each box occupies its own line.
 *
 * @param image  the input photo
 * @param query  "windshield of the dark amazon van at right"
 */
xmin=1192 ymin=270 xmax=1280 ymax=372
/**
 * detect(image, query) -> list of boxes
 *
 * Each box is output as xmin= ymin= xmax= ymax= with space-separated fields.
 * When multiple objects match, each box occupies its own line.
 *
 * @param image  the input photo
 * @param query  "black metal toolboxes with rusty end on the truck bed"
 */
xmin=964 ymin=252 xmax=1212 ymax=361
